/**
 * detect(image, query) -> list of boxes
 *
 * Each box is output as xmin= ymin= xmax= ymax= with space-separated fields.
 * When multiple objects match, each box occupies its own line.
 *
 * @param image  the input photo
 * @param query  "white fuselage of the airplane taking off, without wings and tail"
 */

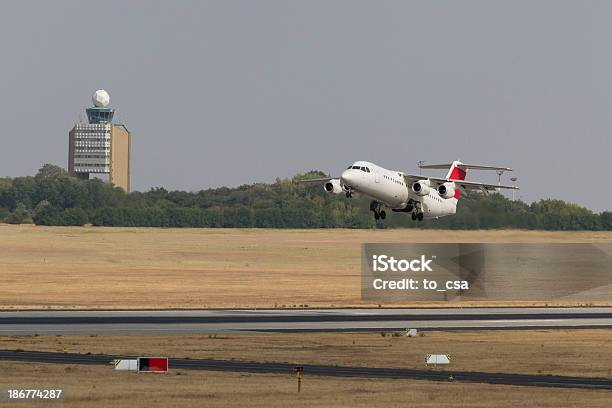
xmin=340 ymin=161 xmax=458 ymax=222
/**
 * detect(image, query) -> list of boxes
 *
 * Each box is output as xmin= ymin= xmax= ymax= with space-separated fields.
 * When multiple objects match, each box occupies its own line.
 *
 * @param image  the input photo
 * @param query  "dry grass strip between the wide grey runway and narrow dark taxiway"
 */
xmin=0 ymin=329 xmax=612 ymax=378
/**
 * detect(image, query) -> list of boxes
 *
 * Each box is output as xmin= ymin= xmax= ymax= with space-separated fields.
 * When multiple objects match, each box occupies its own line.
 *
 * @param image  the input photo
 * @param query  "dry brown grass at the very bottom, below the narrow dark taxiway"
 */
xmin=0 ymin=362 xmax=610 ymax=408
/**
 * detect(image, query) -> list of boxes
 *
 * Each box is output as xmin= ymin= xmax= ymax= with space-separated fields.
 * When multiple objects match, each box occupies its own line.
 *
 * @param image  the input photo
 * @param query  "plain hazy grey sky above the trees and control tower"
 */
xmin=0 ymin=0 xmax=612 ymax=210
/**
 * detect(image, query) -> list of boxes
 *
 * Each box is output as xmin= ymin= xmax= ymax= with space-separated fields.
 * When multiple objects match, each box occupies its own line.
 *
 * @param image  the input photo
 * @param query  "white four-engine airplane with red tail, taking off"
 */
xmin=299 ymin=160 xmax=518 ymax=221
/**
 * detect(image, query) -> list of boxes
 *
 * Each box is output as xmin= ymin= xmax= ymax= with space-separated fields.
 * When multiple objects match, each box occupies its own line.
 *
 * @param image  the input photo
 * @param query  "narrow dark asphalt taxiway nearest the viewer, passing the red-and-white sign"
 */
xmin=0 ymin=350 xmax=612 ymax=390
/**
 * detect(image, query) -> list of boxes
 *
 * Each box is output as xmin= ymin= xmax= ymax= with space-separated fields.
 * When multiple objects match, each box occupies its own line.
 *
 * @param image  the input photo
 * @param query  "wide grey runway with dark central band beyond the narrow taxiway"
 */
xmin=0 ymin=307 xmax=612 ymax=335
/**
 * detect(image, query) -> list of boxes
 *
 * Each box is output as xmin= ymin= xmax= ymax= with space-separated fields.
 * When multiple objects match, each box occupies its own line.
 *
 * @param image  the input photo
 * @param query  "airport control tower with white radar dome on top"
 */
xmin=68 ymin=89 xmax=132 ymax=192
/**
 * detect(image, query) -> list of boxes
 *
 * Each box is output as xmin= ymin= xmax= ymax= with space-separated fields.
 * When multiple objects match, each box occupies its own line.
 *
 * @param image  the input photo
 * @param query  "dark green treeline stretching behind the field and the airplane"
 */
xmin=0 ymin=164 xmax=612 ymax=230
